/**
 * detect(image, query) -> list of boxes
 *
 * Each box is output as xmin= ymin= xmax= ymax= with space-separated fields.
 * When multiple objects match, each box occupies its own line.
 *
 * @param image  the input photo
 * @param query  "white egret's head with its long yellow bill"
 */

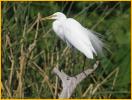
xmin=45 ymin=12 xmax=66 ymax=20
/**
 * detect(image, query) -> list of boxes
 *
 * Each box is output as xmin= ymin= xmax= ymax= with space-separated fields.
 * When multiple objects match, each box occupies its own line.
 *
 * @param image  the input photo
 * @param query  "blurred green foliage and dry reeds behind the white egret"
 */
xmin=2 ymin=1 xmax=131 ymax=98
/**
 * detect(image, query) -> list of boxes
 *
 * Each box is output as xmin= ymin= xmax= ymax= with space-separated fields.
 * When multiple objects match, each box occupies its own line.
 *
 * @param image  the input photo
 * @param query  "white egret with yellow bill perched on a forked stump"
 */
xmin=44 ymin=12 xmax=103 ymax=59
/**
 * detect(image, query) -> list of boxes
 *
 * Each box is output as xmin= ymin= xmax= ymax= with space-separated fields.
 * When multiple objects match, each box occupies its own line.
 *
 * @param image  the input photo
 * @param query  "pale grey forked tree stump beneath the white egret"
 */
xmin=53 ymin=61 xmax=99 ymax=98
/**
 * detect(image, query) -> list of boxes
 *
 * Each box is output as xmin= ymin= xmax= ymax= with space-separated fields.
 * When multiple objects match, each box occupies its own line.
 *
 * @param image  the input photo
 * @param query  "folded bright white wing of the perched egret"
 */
xmin=63 ymin=18 xmax=96 ymax=59
